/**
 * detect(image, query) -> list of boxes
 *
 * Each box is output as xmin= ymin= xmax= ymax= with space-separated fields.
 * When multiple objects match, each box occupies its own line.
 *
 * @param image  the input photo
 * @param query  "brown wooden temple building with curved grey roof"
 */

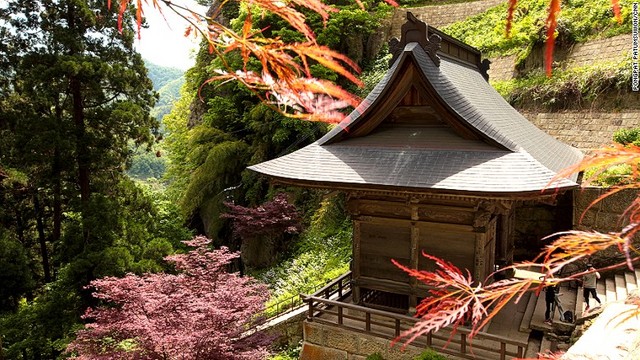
xmin=250 ymin=14 xmax=583 ymax=313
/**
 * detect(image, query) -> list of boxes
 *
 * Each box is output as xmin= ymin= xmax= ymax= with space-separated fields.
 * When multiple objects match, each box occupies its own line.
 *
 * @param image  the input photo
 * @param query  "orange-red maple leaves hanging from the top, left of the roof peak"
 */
xmin=109 ymin=0 xmax=395 ymax=122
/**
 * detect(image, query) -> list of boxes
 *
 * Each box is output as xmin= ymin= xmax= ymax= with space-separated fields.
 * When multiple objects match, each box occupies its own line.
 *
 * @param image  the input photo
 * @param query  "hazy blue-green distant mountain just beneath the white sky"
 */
xmin=144 ymin=60 xmax=185 ymax=120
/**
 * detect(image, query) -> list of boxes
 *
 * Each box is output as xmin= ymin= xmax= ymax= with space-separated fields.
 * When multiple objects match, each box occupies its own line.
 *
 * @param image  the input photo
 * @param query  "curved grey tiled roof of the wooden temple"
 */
xmin=249 ymin=42 xmax=582 ymax=195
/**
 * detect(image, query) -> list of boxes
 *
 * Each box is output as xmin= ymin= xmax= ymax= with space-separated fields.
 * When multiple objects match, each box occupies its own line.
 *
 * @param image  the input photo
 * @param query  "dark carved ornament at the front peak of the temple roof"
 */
xmin=389 ymin=11 xmax=442 ymax=67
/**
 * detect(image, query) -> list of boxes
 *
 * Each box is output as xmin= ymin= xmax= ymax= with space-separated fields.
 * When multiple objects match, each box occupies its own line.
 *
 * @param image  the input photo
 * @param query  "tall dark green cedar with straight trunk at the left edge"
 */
xmin=0 ymin=0 xmax=158 ymax=282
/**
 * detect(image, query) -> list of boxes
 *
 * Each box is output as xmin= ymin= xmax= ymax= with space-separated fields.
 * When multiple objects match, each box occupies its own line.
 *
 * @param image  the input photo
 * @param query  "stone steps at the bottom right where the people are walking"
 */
xmin=519 ymin=269 xmax=640 ymax=359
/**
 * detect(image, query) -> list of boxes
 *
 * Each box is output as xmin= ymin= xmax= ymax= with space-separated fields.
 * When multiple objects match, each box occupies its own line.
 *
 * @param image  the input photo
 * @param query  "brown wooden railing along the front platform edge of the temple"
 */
xmin=301 ymin=273 xmax=527 ymax=360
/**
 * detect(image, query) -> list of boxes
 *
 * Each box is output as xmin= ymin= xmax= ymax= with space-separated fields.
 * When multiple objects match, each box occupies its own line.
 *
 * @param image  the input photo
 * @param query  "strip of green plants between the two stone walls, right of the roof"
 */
xmin=492 ymin=59 xmax=631 ymax=110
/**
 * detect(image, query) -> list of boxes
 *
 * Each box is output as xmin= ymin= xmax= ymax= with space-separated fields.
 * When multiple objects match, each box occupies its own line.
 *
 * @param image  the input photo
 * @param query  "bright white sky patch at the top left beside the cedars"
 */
xmin=135 ymin=0 xmax=206 ymax=70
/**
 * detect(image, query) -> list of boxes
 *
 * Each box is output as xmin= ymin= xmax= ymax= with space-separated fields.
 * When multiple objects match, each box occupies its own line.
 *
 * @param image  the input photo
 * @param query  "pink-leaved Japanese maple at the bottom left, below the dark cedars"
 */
xmin=67 ymin=237 xmax=271 ymax=360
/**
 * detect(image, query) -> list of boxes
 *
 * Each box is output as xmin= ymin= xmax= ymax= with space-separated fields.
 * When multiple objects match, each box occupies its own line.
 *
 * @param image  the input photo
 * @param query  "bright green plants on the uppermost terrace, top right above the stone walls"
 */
xmin=442 ymin=0 xmax=631 ymax=59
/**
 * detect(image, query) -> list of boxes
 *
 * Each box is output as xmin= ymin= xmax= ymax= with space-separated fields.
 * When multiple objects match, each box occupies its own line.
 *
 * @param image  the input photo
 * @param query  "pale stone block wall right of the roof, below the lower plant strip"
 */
xmin=522 ymin=110 xmax=640 ymax=151
